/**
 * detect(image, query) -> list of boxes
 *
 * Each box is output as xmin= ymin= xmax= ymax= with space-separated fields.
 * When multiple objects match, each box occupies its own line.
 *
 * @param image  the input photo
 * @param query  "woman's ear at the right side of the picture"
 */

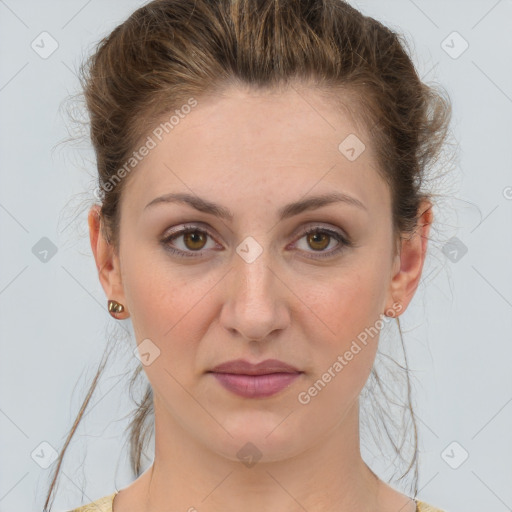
xmin=387 ymin=200 xmax=434 ymax=316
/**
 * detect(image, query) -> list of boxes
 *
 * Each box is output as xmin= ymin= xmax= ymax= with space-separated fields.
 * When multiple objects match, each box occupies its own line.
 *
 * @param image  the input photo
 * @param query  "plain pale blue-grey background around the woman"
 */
xmin=0 ymin=0 xmax=512 ymax=512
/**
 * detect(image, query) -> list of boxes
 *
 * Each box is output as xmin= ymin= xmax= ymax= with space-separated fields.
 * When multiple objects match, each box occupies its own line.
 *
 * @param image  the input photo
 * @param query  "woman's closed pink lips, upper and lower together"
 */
xmin=209 ymin=359 xmax=303 ymax=398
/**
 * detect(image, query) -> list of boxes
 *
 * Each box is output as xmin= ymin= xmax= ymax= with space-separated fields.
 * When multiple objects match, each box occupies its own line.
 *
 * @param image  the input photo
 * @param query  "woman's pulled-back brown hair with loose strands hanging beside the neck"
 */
xmin=44 ymin=0 xmax=451 ymax=511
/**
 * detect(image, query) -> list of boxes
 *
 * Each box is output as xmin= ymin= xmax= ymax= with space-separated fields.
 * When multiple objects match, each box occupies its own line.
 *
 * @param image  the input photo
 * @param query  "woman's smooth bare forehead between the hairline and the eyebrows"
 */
xmin=119 ymin=86 xmax=384 ymax=218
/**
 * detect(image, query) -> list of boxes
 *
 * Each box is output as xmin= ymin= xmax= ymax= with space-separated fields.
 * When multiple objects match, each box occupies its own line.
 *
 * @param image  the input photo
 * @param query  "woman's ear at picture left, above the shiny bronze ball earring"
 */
xmin=88 ymin=204 xmax=129 ymax=319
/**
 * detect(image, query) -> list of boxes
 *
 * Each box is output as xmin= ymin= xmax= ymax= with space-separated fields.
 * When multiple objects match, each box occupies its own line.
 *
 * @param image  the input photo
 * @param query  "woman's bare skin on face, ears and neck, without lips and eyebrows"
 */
xmin=89 ymin=82 xmax=432 ymax=512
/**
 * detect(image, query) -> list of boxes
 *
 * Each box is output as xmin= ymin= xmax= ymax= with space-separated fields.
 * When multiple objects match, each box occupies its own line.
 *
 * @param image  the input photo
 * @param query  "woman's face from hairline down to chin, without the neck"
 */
xmin=91 ymin=88 xmax=421 ymax=460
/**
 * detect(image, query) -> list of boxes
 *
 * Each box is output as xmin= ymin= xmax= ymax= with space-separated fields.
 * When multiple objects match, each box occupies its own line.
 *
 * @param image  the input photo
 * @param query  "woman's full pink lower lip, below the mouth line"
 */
xmin=213 ymin=372 xmax=300 ymax=398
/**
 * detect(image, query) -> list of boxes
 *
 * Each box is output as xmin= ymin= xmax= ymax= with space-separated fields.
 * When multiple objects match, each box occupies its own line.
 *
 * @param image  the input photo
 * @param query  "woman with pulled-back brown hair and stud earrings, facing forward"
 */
xmin=45 ymin=0 xmax=450 ymax=512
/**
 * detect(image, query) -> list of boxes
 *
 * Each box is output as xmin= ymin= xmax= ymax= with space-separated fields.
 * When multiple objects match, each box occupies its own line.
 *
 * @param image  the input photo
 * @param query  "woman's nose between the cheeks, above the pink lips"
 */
xmin=220 ymin=246 xmax=291 ymax=341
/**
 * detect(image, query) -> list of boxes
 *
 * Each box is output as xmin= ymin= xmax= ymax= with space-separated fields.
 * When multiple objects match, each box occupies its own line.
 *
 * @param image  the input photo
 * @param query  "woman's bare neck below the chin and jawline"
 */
xmin=140 ymin=397 xmax=382 ymax=512
